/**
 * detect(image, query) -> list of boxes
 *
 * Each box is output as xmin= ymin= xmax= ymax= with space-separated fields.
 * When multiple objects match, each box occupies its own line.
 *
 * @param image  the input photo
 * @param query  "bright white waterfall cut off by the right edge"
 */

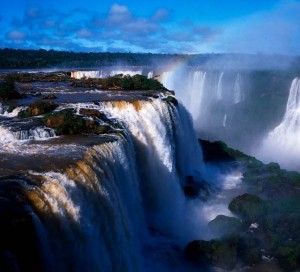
xmin=255 ymin=78 xmax=300 ymax=170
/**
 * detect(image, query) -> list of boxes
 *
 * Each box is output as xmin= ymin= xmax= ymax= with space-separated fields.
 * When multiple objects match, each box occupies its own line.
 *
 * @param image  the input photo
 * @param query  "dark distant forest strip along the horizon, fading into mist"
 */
xmin=0 ymin=49 xmax=190 ymax=69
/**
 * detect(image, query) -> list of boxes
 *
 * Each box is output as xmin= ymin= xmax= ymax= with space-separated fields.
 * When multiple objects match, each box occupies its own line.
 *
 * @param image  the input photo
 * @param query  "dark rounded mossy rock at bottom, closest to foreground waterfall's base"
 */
xmin=185 ymin=237 xmax=238 ymax=270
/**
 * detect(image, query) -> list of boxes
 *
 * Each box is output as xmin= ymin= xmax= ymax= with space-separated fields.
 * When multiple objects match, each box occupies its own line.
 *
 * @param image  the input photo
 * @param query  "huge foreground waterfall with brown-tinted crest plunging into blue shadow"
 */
xmin=21 ymin=99 xmax=204 ymax=272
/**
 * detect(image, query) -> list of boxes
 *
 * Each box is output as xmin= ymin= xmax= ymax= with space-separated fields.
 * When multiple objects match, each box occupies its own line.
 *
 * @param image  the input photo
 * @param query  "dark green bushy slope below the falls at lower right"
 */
xmin=186 ymin=141 xmax=300 ymax=271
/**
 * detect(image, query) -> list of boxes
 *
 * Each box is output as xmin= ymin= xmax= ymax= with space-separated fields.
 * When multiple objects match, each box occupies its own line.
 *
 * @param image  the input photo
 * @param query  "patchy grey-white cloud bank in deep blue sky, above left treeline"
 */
xmin=0 ymin=4 xmax=217 ymax=53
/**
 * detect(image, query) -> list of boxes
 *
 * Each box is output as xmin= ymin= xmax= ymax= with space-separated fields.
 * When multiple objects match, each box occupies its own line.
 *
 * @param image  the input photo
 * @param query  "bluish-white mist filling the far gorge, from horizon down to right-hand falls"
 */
xmin=159 ymin=54 xmax=300 ymax=169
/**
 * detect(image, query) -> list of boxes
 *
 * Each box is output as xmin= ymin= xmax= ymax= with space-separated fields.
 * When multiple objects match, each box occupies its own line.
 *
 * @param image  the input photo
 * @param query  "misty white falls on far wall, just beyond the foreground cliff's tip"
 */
xmin=160 ymin=69 xmax=245 ymax=130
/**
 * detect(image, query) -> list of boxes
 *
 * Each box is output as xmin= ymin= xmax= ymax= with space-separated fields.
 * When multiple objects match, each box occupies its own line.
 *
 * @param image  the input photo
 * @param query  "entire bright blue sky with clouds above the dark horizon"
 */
xmin=0 ymin=0 xmax=300 ymax=55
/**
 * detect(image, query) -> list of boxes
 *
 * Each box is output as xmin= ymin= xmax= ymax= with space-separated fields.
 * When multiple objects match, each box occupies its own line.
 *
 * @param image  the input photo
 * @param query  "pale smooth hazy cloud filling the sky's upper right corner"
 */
xmin=213 ymin=1 xmax=300 ymax=54
